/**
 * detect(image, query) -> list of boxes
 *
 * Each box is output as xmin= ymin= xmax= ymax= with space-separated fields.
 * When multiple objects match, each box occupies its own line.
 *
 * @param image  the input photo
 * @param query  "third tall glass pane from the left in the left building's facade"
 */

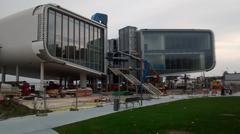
xmin=62 ymin=15 xmax=68 ymax=60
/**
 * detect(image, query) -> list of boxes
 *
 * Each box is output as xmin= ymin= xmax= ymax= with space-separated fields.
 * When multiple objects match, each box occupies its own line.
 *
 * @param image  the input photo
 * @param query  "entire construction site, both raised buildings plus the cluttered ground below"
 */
xmin=0 ymin=4 xmax=237 ymax=118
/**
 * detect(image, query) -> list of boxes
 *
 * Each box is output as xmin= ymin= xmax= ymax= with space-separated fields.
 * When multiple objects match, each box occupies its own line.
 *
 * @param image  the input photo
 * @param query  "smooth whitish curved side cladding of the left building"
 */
xmin=0 ymin=8 xmax=40 ymax=64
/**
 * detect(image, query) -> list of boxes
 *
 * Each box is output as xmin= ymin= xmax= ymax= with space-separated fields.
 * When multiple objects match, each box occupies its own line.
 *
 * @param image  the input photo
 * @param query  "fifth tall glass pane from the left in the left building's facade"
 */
xmin=74 ymin=20 xmax=80 ymax=64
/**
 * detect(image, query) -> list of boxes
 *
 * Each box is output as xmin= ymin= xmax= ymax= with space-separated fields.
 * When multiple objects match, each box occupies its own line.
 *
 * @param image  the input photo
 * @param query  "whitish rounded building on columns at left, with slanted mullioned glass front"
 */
xmin=0 ymin=4 xmax=107 ymax=87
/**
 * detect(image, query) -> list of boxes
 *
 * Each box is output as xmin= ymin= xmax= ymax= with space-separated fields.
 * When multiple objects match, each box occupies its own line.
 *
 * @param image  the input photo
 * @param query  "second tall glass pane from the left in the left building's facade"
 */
xmin=55 ymin=13 xmax=62 ymax=58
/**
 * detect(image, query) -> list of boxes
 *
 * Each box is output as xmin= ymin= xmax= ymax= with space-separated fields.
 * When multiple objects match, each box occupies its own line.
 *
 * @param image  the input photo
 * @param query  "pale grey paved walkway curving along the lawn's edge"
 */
xmin=0 ymin=95 xmax=202 ymax=134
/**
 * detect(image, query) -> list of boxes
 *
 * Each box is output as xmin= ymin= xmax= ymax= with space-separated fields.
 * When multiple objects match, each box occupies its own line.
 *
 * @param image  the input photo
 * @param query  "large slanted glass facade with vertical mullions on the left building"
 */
xmin=47 ymin=9 xmax=104 ymax=72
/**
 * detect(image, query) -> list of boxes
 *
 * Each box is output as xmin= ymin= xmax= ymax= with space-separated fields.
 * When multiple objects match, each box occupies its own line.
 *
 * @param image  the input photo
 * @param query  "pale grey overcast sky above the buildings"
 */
xmin=0 ymin=0 xmax=240 ymax=80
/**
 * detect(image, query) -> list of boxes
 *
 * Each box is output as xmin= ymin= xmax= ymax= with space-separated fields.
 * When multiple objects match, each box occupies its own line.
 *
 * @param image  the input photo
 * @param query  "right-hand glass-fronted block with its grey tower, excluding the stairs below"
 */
xmin=109 ymin=26 xmax=216 ymax=76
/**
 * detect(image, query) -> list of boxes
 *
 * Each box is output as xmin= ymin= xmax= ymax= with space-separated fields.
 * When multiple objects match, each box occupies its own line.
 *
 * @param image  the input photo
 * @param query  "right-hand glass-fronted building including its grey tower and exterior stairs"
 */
xmin=108 ymin=26 xmax=215 ymax=95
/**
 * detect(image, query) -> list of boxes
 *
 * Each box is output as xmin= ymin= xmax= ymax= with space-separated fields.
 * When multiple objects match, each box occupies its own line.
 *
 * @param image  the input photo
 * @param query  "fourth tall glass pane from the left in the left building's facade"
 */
xmin=68 ymin=18 xmax=75 ymax=62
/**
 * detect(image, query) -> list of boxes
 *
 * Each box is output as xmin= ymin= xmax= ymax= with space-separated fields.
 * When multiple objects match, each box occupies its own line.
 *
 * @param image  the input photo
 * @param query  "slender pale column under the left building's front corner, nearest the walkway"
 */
xmin=40 ymin=62 xmax=47 ymax=110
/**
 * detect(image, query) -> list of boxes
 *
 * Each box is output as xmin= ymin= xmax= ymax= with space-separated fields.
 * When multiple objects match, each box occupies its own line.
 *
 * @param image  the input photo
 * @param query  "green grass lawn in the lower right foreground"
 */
xmin=55 ymin=97 xmax=240 ymax=134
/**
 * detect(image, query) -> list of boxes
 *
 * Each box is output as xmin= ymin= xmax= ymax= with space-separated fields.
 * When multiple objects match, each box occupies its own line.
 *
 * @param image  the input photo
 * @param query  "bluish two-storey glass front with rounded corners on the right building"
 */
xmin=142 ymin=31 xmax=215 ymax=74
